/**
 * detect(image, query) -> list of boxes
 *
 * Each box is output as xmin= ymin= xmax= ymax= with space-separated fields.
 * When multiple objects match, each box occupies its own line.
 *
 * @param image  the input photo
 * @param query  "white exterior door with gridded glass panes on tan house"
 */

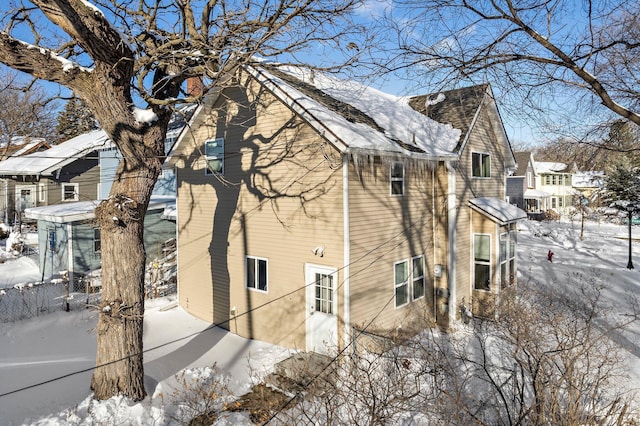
xmin=305 ymin=264 xmax=338 ymax=355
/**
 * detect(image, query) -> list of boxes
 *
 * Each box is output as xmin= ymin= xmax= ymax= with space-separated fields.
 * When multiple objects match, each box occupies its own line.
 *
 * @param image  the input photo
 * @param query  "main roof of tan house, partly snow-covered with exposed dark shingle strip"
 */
xmin=247 ymin=63 xmax=462 ymax=158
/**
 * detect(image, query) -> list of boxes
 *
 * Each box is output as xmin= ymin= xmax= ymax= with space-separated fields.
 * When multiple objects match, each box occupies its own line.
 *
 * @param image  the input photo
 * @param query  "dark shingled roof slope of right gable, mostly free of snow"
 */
xmin=409 ymin=83 xmax=489 ymax=152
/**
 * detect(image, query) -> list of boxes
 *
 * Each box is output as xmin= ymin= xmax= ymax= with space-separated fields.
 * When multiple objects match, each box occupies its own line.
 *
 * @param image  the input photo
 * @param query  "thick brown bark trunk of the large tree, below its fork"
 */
xmin=91 ymin=152 xmax=160 ymax=401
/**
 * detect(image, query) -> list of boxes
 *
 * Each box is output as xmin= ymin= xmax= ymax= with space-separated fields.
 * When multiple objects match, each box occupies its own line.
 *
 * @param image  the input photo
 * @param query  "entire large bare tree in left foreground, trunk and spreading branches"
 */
xmin=0 ymin=0 xmax=366 ymax=400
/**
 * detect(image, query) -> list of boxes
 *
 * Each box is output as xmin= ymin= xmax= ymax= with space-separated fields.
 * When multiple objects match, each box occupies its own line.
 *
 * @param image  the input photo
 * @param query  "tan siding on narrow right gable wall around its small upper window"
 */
xmin=455 ymin=109 xmax=505 ymax=317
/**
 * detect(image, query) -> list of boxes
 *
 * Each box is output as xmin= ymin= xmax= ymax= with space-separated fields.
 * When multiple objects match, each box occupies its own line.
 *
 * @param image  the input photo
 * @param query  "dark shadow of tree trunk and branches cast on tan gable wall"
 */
xmin=178 ymin=72 xmax=330 ymax=346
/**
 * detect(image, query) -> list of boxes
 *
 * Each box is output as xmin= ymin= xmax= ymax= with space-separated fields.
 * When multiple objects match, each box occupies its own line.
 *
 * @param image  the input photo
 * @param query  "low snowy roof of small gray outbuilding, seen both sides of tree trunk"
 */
xmin=24 ymin=195 xmax=176 ymax=223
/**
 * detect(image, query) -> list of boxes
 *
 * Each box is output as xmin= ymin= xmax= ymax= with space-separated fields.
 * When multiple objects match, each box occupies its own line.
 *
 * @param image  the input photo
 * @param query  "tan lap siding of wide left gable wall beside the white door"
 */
xmin=178 ymin=76 xmax=343 ymax=348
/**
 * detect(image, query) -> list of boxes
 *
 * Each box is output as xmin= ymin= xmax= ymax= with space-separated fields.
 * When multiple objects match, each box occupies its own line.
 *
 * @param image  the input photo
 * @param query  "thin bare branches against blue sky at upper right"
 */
xmin=387 ymin=0 xmax=640 ymax=143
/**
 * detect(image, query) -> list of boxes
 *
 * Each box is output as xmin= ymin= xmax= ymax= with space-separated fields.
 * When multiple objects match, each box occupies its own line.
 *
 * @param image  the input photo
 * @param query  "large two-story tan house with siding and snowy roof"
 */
xmin=168 ymin=63 xmax=526 ymax=352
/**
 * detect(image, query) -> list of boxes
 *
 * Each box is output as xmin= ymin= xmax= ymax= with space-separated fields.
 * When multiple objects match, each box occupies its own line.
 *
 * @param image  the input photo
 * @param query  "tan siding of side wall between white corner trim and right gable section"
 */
xmin=349 ymin=160 xmax=434 ymax=333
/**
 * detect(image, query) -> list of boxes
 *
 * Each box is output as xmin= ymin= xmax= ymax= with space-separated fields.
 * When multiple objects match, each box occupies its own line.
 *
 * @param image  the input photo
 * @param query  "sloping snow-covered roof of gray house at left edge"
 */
xmin=0 ymin=130 xmax=115 ymax=176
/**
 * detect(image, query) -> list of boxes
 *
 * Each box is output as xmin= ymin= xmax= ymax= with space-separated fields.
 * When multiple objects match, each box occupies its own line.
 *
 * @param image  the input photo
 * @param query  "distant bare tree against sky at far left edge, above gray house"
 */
xmin=0 ymin=70 xmax=56 ymax=159
